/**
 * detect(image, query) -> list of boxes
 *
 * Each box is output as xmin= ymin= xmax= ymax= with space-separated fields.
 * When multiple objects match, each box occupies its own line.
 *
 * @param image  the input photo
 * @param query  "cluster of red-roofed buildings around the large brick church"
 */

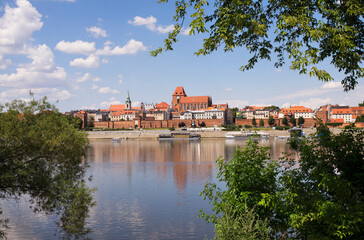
xmin=69 ymin=87 xmax=233 ymax=126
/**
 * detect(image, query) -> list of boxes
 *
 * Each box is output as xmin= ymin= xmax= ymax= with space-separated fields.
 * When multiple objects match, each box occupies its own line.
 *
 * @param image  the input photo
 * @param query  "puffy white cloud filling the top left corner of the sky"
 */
xmin=0 ymin=0 xmax=43 ymax=55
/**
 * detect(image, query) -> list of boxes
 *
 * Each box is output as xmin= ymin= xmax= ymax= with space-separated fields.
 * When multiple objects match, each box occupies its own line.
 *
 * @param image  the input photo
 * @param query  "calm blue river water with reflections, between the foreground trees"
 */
xmin=2 ymin=140 xmax=296 ymax=239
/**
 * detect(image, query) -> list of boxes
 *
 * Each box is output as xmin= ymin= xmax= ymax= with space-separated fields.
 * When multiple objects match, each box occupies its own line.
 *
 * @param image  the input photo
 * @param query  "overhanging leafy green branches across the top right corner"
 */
xmin=151 ymin=0 xmax=364 ymax=91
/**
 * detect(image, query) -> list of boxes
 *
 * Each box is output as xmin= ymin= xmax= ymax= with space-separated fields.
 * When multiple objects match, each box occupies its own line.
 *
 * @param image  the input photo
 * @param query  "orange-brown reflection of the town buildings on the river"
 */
xmin=87 ymin=139 xmax=297 ymax=192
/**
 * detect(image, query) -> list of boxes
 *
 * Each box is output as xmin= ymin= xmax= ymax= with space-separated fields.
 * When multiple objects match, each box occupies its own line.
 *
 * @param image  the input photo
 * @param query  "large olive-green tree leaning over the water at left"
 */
xmin=0 ymin=98 xmax=94 ymax=238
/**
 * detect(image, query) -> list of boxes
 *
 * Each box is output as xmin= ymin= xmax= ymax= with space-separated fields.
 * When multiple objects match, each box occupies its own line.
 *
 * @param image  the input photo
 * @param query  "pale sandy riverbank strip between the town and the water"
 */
xmin=87 ymin=128 xmax=342 ymax=139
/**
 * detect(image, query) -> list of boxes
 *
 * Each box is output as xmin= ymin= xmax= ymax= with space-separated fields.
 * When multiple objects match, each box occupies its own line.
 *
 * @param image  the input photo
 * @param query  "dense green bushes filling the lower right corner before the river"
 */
xmin=201 ymin=125 xmax=364 ymax=239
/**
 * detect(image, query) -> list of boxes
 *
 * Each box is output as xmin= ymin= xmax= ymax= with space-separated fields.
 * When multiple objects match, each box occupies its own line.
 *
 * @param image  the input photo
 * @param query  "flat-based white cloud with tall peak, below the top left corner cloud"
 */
xmin=0 ymin=44 xmax=67 ymax=88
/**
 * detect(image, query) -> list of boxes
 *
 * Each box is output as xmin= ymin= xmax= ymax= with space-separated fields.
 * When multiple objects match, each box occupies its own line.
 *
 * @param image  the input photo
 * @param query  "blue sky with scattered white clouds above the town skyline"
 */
xmin=0 ymin=0 xmax=364 ymax=112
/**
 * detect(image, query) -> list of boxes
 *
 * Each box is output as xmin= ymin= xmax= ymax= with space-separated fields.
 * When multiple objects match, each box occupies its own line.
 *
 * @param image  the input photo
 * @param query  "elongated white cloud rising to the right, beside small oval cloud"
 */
xmin=96 ymin=39 xmax=147 ymax=56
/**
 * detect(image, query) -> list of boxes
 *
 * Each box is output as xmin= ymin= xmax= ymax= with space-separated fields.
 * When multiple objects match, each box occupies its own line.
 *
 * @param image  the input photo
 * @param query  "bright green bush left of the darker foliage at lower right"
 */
xmin=200 ymin=140 xmax=278 ymax=239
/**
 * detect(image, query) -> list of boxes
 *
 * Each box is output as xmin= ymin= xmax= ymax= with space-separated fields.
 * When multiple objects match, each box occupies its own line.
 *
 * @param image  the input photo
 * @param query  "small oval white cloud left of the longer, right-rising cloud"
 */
xmin=55 ymin=40 xmax=96 ymax=55
